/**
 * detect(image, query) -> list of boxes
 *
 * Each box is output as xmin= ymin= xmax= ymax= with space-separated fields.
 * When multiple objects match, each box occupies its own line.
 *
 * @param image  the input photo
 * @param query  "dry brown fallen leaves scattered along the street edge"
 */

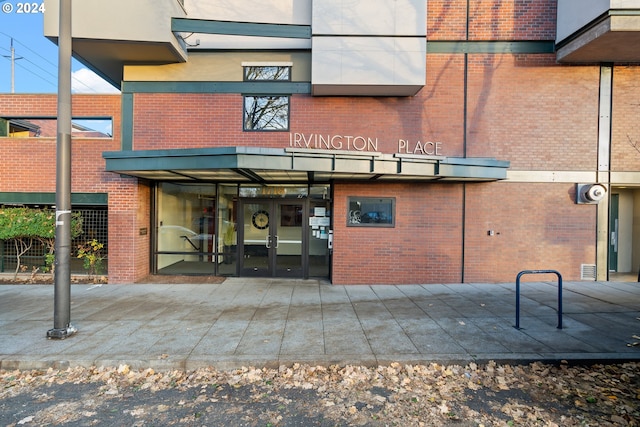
xmin=0 ymin=362 xmax=640 ymax=427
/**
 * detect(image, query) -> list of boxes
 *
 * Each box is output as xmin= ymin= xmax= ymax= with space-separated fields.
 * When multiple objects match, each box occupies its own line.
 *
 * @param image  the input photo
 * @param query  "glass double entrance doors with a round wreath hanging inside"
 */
xmin=240 ymin=199 xmax=306 ymax=277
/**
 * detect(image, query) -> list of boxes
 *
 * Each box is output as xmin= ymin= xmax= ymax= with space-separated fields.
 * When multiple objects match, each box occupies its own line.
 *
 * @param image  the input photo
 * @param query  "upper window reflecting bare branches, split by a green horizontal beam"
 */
xmin=243 ymin=64 xmax=291 ymax=131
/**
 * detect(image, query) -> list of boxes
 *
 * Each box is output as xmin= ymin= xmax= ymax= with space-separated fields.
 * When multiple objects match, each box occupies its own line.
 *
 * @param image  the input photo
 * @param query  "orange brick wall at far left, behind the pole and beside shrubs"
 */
xmin=0 ymin=94 xmax=151 ymax=283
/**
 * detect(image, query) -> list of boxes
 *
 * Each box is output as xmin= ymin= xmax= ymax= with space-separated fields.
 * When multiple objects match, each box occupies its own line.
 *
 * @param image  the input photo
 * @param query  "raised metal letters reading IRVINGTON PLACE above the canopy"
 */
xmin=289 ymin=132 xmax=442 ymax=156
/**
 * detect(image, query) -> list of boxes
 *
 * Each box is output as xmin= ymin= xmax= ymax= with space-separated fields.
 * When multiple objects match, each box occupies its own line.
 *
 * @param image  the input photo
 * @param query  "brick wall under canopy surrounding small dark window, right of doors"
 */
xmin=332 ymin=183 xmax=462 ymax=284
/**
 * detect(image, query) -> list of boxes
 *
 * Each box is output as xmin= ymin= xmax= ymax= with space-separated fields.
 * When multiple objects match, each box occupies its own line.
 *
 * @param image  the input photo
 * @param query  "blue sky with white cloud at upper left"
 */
xmin=0 ymin=0 xmax=118 ymax=93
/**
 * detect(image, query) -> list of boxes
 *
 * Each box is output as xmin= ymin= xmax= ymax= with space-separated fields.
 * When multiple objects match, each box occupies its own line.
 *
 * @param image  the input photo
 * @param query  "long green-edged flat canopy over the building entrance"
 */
xmin=103 ymin=147 xmax=509 ymax=183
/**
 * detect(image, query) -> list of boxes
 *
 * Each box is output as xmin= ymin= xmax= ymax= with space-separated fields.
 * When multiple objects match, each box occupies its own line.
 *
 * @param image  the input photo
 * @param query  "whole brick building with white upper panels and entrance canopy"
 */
xmin=0 ymin=0 xmax=640 ymax=284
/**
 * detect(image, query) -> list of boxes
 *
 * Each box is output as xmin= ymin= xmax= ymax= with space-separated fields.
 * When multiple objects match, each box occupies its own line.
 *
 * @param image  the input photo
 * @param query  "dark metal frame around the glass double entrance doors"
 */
xmin=236 ymin=197 xmax=309 ymax=279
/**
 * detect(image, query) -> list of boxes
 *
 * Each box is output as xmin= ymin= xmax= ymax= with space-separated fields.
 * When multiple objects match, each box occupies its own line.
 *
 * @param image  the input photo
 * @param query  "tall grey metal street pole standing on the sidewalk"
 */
xmin=47 ymin=0 xmax=77 ymax=339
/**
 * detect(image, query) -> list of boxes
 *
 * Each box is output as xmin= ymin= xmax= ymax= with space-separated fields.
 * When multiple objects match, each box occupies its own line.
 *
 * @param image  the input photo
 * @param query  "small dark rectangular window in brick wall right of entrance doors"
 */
xmin=347 ymin=197 xmax=396 ymax=227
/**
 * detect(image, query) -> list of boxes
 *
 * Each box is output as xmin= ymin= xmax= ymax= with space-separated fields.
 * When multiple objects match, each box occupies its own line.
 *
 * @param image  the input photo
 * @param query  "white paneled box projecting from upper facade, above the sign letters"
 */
xmin=311 ymin=0 xmax=427 ymax=95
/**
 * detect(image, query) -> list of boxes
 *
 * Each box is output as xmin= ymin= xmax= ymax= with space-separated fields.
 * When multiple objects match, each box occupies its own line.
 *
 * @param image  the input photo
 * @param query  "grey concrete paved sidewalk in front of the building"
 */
xmin=0 ymin=278 xmax=640 ymax=370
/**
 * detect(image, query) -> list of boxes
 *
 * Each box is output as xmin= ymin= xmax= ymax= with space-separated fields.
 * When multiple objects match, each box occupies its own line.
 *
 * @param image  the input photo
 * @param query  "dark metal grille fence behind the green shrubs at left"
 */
xmin=0 ymin=206 xmax=109 ymax=274
